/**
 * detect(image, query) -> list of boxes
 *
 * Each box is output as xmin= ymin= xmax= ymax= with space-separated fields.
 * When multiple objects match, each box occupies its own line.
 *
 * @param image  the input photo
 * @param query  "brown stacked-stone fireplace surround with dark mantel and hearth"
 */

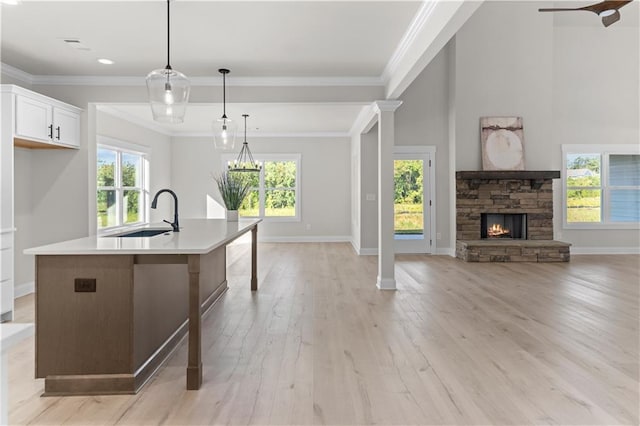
xmin=456 ymin=170 xmax=570 ymax=262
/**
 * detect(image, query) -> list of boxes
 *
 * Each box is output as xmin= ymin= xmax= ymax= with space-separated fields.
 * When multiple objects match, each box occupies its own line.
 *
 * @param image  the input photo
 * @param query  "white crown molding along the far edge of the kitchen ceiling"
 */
xmin=1 ymin=63 xmax=384 ymax=87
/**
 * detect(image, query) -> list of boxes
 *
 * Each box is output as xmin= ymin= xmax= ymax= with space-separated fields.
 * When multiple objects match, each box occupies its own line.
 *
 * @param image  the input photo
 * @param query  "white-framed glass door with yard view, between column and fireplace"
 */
xmin=393 ymin=152 xmax=431 ymax=253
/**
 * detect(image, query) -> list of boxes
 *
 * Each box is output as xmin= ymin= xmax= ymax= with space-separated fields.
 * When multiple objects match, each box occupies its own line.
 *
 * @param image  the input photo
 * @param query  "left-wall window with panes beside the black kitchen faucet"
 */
xmin=96 ymin=144 xmax=149 ymax=231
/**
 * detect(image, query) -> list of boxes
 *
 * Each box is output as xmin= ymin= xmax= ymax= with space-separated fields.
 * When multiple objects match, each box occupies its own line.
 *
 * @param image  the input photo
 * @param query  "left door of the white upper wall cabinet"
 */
xmin=16 ymin=96 xmax=53 ymax=142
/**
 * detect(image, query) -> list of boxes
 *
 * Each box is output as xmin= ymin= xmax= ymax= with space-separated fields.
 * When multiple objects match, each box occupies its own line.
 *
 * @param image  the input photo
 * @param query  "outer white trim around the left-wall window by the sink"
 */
xmin=94 ymin=135 xmax=151 ymax=235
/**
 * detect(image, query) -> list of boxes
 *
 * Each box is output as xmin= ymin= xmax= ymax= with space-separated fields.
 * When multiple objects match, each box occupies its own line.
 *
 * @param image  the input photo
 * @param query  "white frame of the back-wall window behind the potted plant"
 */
xmin=221 ymin=153 xmax=302 ymax=222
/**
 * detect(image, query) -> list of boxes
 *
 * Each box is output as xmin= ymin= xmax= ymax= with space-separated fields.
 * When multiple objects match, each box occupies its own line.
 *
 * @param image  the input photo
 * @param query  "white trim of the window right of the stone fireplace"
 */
xmin=561 ymin=144 xmax=640 ymax=229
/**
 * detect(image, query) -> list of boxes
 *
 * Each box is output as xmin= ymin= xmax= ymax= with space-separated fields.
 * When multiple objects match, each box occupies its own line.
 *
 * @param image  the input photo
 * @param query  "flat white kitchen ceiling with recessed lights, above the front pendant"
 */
xmin=2 ymin=0 xmax=421 ymax=77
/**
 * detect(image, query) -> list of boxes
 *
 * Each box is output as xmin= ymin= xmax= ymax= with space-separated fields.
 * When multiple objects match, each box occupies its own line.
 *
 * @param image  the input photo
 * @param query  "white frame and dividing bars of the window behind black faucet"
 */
xmin=95 ymin=136 xmax=151 ymax=235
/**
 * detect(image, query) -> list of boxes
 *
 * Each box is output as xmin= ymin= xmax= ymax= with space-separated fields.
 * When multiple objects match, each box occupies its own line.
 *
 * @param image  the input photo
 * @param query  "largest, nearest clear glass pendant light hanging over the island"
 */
xmin=147 ymin=0 xmax=191 ymax=123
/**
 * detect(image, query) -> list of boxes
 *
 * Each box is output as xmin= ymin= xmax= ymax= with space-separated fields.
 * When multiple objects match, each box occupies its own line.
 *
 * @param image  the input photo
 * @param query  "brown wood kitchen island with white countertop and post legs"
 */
xmin=25 ymin=219 xmax=260 ymax=396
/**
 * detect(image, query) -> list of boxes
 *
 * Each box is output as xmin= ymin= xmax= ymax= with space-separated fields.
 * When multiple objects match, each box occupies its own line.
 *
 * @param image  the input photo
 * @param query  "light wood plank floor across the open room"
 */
xmin=9 ymin=243 xmax=640 ymax=425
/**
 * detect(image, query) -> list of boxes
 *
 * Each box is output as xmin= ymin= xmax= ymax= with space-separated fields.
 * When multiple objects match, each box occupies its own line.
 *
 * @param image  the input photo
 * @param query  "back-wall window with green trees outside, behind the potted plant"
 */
xmin=223 ymin=154 xmax=300 ymax=221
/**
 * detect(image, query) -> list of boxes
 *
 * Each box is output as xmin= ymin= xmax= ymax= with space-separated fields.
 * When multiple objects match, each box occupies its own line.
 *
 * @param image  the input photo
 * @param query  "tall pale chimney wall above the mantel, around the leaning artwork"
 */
xmin=455 ymin=1 xmax=560 ymax=170
